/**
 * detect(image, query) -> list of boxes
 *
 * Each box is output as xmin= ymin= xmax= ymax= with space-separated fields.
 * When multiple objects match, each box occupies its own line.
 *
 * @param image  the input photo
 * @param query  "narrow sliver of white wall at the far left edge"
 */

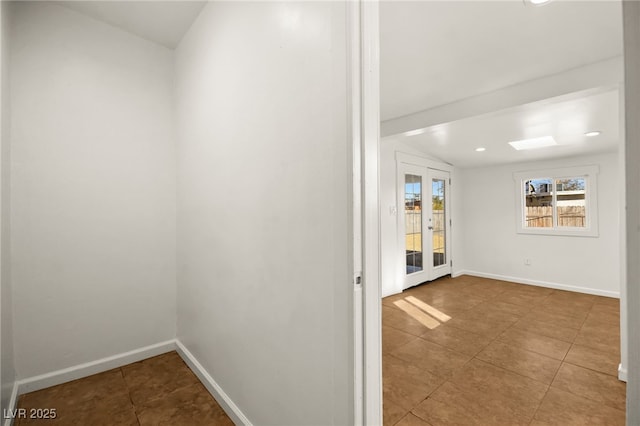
xmin=0 ymin=2 xmax=15 ymax=412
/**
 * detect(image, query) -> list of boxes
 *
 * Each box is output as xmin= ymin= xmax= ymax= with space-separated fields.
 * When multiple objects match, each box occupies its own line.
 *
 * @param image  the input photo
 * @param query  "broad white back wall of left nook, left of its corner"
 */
xmin=10 ymin=2 xmax=176 ymax=378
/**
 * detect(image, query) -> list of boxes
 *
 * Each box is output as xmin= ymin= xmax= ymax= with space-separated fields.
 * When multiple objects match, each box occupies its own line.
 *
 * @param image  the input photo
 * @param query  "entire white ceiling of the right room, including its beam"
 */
xmin=380 ymin=0 xmax=622 ymax=167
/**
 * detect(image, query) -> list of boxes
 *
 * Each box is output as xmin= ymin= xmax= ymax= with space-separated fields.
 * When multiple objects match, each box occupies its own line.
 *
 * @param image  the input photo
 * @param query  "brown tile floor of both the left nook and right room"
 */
xmin=10 ymin=276 xmax=625 ymax=426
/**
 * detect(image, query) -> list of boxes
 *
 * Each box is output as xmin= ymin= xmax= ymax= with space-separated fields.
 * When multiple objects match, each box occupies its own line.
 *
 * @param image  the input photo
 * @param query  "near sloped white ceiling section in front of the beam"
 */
xmin=380 ymin=0 xmax=622 ymax=122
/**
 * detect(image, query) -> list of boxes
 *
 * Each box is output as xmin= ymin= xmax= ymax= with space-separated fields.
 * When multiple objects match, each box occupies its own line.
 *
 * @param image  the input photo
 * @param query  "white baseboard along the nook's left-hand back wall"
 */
xmin=16 ymin=340 xmax=176 ymax=395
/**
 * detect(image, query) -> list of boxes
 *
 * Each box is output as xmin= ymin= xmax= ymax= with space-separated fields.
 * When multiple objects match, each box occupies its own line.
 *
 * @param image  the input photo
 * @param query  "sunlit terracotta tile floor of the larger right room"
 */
xmin=382 ymin=276 xmax=626 ymax=426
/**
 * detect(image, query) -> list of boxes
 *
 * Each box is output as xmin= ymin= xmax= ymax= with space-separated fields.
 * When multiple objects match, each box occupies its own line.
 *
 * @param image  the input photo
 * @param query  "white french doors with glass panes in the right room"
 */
xmin=398 ymin=163 xmax=451 ymax=289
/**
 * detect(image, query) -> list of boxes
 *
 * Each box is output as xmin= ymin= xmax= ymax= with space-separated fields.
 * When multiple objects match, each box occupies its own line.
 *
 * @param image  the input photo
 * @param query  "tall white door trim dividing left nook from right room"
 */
xmin=347 ymin=0 xmax=382 ymax=425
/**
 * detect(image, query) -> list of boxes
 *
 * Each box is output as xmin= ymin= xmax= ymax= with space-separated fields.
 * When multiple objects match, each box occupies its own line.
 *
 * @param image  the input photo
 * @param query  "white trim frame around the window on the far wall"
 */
xmin=513 ymin=165 xmax=599 ymax=237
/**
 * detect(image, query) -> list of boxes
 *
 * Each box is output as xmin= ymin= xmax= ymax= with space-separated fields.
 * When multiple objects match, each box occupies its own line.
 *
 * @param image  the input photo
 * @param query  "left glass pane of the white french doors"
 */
xmin=404 ymin=174 xmax=423 ymax=275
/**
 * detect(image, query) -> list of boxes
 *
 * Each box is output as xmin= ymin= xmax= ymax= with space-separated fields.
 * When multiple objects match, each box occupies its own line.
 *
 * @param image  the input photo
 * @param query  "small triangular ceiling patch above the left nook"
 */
xmin=56 ymin=1 xmax=207 ymax=49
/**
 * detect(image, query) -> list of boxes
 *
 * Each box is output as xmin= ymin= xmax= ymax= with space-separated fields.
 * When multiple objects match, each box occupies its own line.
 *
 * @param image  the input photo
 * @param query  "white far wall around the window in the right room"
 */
xmin=459 ymin=152 xmax=623 ymax=297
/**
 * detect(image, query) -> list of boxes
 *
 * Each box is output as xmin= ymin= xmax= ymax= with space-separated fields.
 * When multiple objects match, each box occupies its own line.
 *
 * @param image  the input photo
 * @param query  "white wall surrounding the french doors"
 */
xmin=380 ymin=138 xmax=460 ymax=297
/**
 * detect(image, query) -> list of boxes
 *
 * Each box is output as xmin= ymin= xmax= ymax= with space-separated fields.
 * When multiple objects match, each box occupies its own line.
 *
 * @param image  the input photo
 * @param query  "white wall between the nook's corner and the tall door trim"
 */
xmin=176 ymin=2 xmax=353 ymax=425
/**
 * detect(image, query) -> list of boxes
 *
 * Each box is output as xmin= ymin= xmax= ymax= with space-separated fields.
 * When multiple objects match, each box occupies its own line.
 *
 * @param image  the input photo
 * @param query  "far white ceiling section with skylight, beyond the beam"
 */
xmin=390 ymin=89 xmax=620 ymax=168
